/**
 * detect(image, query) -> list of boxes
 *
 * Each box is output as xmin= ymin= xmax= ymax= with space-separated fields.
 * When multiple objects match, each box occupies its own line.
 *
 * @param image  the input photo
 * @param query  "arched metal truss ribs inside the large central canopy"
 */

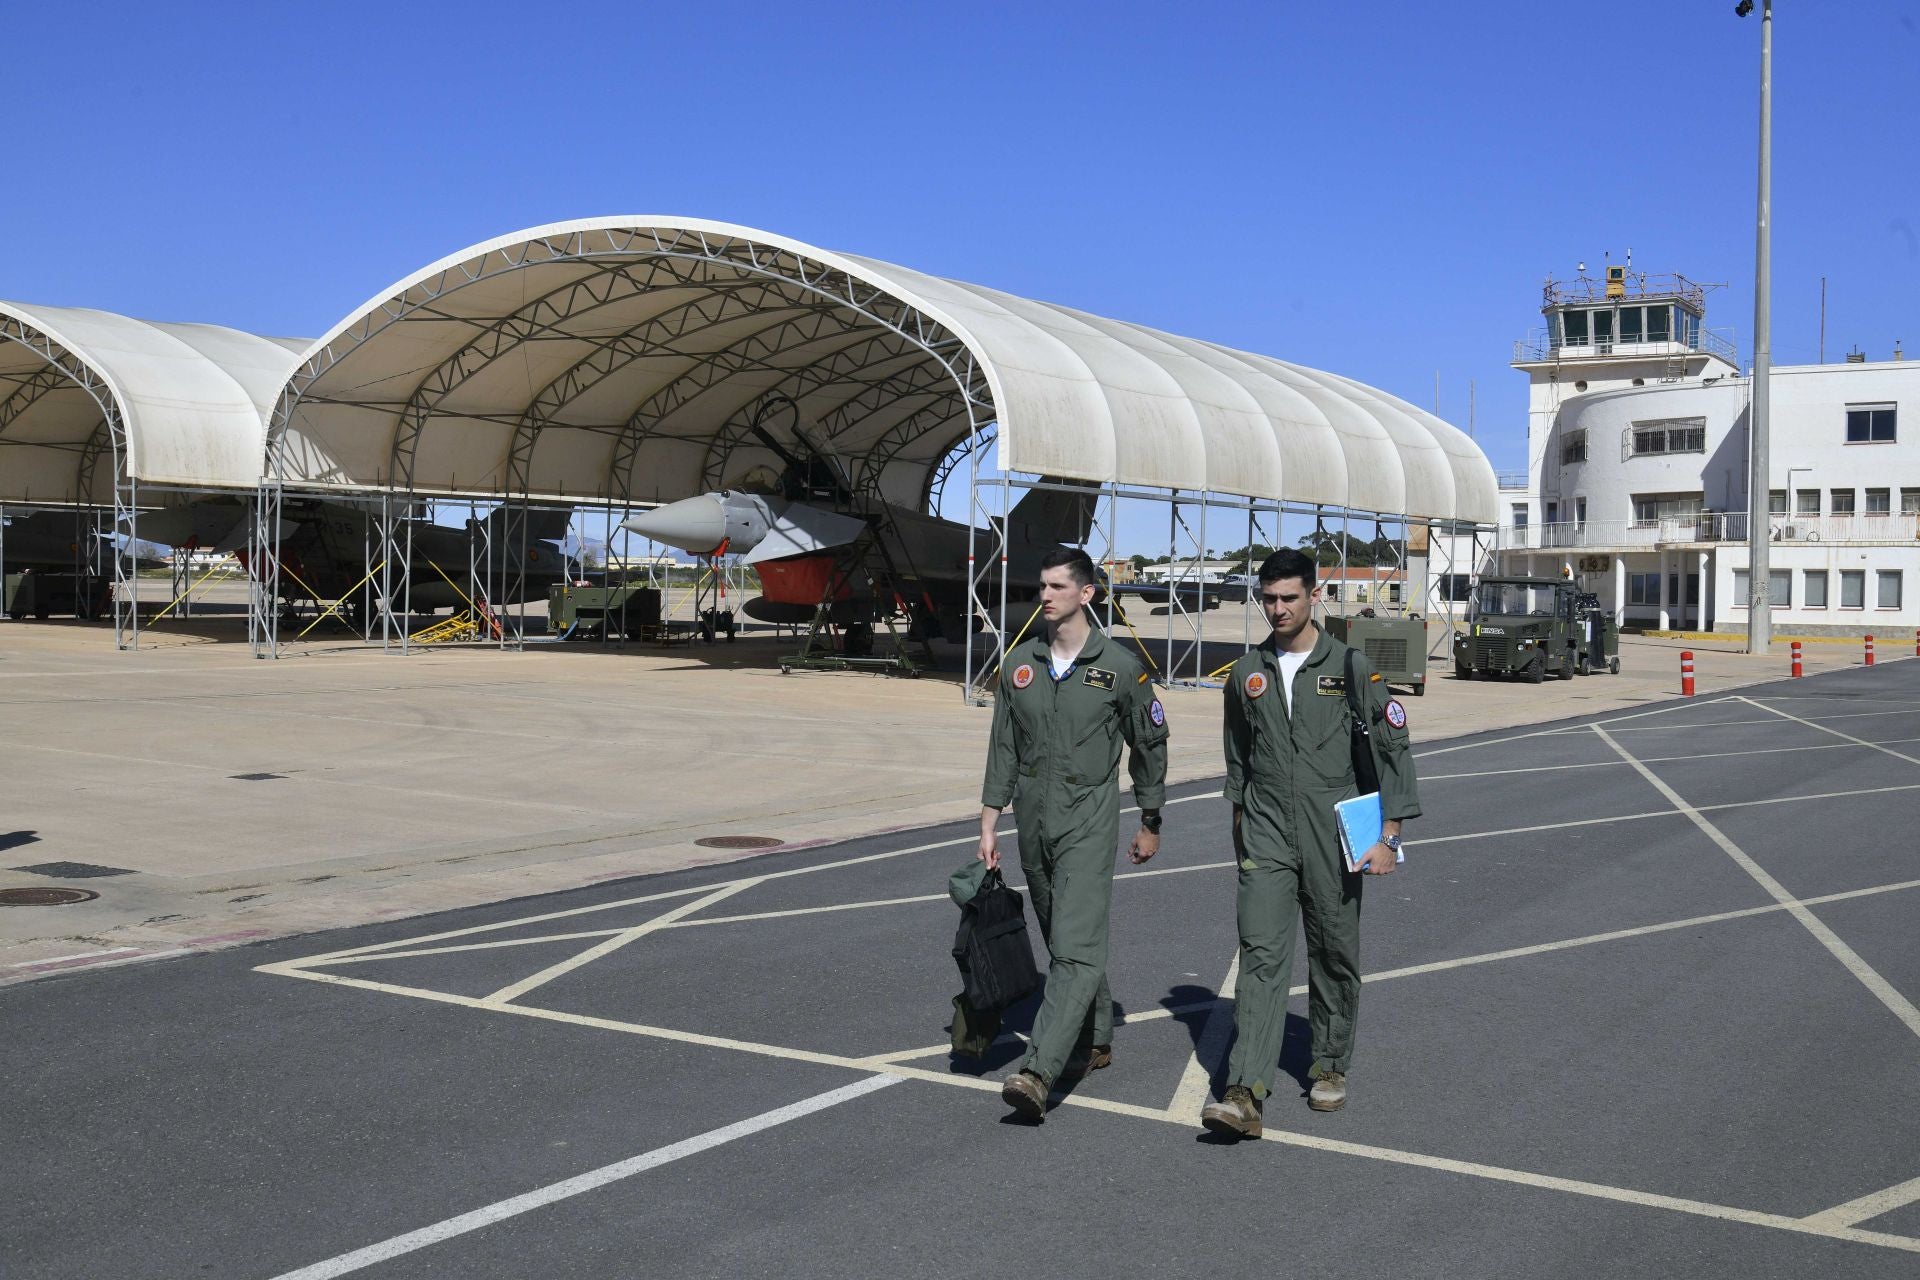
xmin=250 ymin=228 xmax=991 ymax=656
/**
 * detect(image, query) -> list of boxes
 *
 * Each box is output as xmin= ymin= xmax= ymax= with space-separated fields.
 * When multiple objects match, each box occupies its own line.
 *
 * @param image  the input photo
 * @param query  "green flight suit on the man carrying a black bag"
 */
xmin=981 ymin=628 xmax=1167 ymax=1084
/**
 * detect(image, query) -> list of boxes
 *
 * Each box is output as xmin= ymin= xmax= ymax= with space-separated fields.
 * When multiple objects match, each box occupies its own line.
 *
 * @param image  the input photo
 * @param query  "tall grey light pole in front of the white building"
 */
xmin=1734 ymin=0 xmax=1774 ymax=652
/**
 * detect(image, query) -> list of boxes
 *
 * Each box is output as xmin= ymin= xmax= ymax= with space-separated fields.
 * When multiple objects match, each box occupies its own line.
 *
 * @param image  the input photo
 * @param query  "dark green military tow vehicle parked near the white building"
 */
xmin=1453 ymin=578 xmax=1620 ymax=685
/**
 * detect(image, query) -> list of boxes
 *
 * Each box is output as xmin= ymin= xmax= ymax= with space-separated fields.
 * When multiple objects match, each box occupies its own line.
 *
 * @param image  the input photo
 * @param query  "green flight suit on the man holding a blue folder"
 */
xmin=1225 ymin=631 xmax=1421 ymax=1098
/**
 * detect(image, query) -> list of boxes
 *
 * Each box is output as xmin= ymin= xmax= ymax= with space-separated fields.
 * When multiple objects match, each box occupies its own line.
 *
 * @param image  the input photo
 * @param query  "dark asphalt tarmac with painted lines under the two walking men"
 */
xmin=0 ymin=662 xmax=1920 ymax=1280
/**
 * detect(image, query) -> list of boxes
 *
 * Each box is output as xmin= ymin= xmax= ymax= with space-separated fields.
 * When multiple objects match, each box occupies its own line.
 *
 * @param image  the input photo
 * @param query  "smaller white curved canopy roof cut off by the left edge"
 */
xmin=0 ymin=301 xmax=309 ymax=507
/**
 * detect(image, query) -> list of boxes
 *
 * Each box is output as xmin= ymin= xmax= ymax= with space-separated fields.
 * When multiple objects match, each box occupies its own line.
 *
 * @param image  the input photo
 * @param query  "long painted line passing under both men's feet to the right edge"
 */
xmin=263 ymin=965 xmax=1920 ymax=1258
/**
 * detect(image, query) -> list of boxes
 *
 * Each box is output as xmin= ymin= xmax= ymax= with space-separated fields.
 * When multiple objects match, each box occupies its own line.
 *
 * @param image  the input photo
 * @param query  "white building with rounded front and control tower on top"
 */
xmin=1463 ymin=267 xmax=1920 ymax=639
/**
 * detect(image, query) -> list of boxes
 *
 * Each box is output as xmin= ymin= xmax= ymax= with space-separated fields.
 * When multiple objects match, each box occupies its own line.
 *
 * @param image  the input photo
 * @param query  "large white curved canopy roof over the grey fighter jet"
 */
xmin=275 ymin=217 xmax=1496 ymax=522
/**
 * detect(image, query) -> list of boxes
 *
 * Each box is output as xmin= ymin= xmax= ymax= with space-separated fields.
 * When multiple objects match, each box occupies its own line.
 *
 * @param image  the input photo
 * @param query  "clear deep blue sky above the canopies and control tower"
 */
xmin=0 ymin=0 xmax=1920 ymax=479
